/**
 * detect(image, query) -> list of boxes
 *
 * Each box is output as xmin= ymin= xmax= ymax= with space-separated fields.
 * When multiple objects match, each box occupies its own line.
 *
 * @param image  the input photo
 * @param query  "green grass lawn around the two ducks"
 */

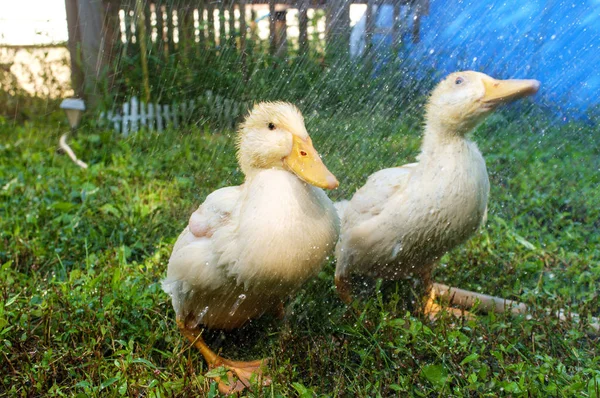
xmin=0 ymin=110 xmax=600 ymax=397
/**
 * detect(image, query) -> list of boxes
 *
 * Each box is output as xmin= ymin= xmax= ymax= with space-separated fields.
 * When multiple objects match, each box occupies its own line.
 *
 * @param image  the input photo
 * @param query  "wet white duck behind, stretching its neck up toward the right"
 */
xmin=335 ymin=71 xmax=540 ymax=317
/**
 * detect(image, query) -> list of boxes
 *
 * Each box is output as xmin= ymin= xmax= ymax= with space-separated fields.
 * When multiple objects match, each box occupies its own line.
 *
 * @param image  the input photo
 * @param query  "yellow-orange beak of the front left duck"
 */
xmin=283 ymin=135 xmax=340 ymax=189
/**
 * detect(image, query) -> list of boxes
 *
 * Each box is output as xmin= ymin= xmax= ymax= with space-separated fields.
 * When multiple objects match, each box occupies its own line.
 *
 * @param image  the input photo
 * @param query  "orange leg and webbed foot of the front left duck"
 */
xmin=177 ymin=320 xmax=271 ymax=394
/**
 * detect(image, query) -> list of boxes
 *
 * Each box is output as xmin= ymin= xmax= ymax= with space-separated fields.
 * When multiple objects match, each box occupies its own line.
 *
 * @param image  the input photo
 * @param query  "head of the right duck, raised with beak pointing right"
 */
xmin=426 ymin=71 xmax=540 ymax=136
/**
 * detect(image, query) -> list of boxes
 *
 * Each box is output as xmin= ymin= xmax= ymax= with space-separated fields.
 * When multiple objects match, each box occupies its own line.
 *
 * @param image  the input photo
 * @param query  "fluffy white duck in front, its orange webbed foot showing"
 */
xmin=162 ymin=102 xmax=340 ymax=393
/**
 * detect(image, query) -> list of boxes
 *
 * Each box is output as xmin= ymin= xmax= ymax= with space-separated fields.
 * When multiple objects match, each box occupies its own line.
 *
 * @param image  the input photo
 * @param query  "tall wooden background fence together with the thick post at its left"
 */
xmin=65 ymin=0 xmax=429 ymax=107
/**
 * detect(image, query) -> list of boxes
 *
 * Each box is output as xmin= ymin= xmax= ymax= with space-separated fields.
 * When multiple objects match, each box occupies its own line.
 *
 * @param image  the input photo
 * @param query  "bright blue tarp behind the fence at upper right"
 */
xmin=351 ymin=0 xmax=600 ymax=114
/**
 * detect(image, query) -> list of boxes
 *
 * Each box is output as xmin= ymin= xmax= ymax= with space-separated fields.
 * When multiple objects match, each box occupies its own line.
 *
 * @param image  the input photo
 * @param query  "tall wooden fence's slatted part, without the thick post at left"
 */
xmin=105 ymin=0 xmax=429 ymax=55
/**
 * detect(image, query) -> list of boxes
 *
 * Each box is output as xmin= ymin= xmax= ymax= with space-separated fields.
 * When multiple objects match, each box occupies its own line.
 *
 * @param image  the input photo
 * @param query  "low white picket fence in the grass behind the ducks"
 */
xmin=100 ymin=91 xmax=251 ymax=136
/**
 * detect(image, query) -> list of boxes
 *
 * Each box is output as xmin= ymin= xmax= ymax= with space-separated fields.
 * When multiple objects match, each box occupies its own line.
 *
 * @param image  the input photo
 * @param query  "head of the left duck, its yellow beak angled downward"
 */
xmin=237 ymin=102 xmax=339 ymax=189
